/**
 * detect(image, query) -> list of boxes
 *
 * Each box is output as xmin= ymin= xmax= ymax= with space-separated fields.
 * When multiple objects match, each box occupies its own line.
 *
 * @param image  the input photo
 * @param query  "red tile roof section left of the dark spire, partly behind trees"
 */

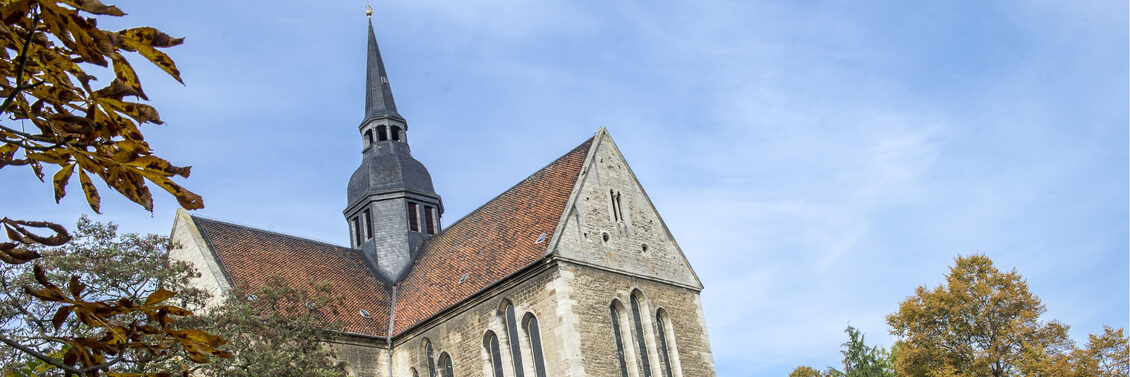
xmin=192 ymin=217 xmax=390 ymax=336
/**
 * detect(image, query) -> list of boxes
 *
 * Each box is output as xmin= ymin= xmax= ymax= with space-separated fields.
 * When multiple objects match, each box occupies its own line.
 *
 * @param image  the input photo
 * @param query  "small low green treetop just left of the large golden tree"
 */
xmin=789 ymin=326 xmax=895 ymax=377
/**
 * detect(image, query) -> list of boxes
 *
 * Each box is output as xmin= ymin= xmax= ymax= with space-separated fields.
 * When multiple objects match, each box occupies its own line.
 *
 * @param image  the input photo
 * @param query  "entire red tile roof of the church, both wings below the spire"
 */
xmin=192 ymin=139 xmax=592 ymax=337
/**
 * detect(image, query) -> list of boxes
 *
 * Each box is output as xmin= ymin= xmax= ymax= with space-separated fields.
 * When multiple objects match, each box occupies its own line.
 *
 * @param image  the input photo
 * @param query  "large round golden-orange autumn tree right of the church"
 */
xmin=887 ymin=255 xmax=1111 ymax=377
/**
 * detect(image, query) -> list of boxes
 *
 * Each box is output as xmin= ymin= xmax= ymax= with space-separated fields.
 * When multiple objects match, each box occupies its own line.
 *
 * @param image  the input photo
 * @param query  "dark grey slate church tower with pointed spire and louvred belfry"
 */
xmin=344 ymin=21 xmax=443 ymax=283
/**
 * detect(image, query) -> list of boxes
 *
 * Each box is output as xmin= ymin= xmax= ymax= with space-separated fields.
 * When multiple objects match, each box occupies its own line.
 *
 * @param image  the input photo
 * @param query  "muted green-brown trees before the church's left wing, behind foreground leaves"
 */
xmin=0 ymin=217 xmax=344 ymax=377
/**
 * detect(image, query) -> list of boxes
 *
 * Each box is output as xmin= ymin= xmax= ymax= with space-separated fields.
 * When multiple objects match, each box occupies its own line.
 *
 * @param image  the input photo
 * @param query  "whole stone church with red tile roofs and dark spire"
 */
xmin=171 ymin=19 xmax=715 ymax=377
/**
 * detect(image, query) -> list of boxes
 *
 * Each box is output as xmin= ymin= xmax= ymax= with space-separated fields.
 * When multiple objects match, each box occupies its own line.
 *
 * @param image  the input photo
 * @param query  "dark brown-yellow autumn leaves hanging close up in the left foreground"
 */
xmin=0 ymin=0 xmax=220 ymax=370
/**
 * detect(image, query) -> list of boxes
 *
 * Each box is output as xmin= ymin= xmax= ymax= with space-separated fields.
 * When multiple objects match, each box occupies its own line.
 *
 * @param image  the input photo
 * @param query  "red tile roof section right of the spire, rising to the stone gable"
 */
xmin=393 ymin=139 xmax=592 ymax=333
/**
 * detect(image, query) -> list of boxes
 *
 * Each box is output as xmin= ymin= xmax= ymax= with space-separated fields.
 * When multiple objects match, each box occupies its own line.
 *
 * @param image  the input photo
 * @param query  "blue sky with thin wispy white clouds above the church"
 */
xmin=0 ymin=0 xmax=1130 ymax=376
